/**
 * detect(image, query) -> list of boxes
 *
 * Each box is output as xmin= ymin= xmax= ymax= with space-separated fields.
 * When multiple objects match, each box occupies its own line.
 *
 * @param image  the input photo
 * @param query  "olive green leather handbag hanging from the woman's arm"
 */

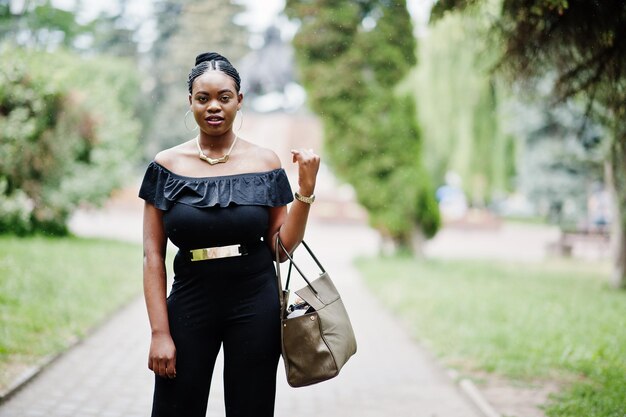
xmin=276 ymin=238 xmax=356 ymax=387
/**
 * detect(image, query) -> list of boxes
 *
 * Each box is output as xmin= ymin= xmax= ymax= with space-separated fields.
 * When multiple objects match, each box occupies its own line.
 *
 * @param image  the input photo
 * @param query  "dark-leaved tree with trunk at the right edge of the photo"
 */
xmin=433 ymin=0 xmax=626 ymax=288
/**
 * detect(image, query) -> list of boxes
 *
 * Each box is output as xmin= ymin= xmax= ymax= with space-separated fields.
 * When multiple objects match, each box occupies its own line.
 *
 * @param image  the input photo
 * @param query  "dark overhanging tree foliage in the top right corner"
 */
xmin=480 ymin=0 xmax=626 ymax=107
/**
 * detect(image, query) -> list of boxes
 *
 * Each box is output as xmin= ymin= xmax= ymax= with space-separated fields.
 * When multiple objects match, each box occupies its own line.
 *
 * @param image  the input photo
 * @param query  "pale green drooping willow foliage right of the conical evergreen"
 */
xmin=408 ymin=10 xmax=515 ymax=205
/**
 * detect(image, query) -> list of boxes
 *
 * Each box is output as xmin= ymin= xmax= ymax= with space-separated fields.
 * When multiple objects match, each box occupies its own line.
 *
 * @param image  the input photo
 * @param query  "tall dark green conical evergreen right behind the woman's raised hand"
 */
xmin=286 ymin=0 xmax=439 ymax=246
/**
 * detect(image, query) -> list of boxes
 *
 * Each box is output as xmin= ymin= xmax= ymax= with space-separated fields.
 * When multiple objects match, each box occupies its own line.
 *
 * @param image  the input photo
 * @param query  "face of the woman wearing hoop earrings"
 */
xmin=189 ymin=71 xmax=243 ymax=135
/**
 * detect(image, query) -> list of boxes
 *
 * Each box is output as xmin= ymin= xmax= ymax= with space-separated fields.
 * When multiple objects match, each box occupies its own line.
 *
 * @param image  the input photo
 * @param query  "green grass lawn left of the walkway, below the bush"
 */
xmin=0 ymin=237 xmax=142 ymax=390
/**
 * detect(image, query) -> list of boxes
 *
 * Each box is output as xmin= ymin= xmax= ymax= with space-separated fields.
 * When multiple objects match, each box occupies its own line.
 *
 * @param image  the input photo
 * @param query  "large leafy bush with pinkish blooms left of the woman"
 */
xmin=0 ymin=45 xmax=139 ymax=234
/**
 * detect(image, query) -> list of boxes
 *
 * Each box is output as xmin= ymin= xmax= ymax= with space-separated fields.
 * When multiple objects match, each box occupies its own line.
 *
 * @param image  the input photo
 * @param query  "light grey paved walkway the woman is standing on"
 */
xmin=0 ymin=211 xmax=479 ymax=417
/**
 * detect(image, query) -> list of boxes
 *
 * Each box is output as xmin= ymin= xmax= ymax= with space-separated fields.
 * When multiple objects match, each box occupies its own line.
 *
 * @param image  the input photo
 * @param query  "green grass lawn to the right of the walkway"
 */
xmin=357 ymin=257 xmax=626 ymax=417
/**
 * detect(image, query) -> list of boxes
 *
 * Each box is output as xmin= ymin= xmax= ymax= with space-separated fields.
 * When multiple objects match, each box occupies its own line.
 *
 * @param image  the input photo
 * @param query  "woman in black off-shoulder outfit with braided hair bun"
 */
xmin=139 ymin=53 xmax=319 ymax=417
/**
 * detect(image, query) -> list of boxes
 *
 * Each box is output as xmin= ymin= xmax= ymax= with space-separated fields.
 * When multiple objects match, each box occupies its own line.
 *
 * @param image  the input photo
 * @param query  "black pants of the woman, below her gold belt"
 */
xmin=152 ymin=250 xmax=280 ymax=417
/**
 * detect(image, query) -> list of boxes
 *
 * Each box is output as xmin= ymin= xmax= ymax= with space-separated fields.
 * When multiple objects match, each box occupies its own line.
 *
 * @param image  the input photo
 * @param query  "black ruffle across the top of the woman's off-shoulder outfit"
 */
xmin=139 ymin=161 xmax=293 ymax=210
